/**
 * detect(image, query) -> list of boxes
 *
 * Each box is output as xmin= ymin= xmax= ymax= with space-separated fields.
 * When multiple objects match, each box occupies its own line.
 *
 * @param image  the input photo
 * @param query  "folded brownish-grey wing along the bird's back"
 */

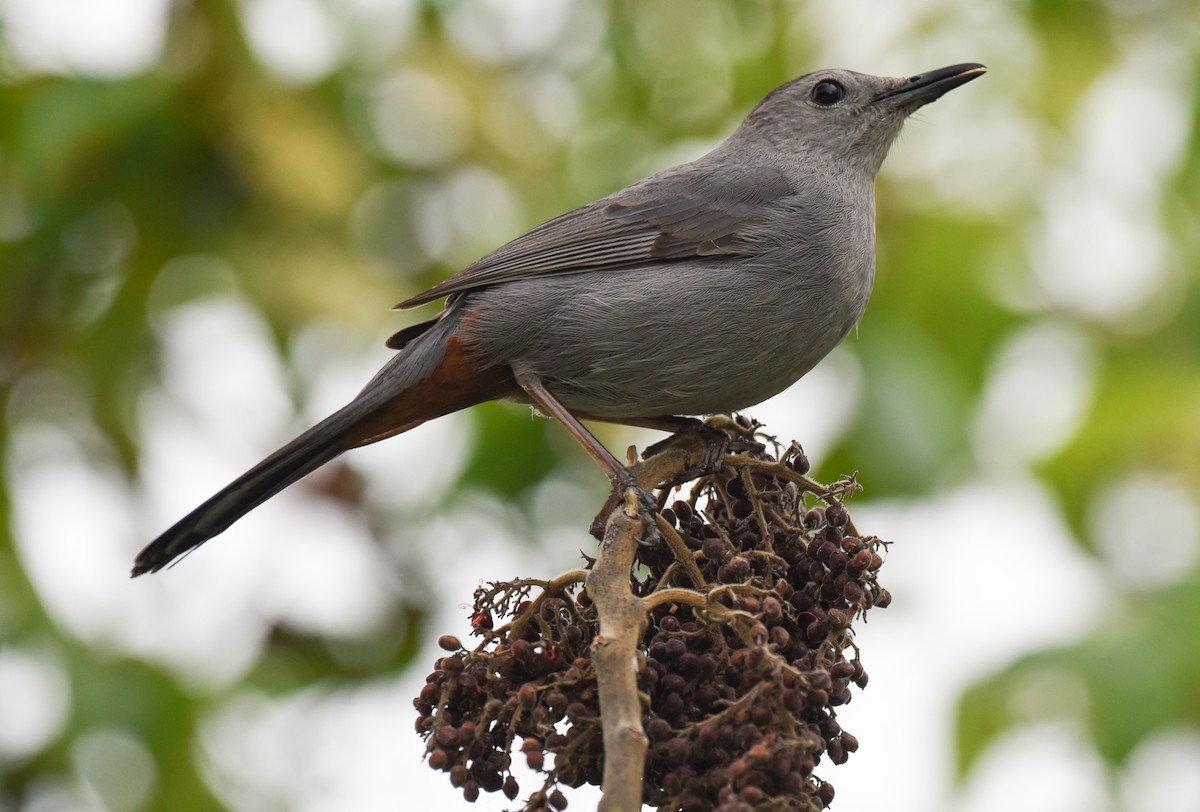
xmin=396 ymin=164 xmax=794 ymax=308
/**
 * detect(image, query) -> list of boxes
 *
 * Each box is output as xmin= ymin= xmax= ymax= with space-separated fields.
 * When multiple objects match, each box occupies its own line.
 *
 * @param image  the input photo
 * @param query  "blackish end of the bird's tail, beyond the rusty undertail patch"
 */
xmin=132 ymin=404 xmax=360 ymax=578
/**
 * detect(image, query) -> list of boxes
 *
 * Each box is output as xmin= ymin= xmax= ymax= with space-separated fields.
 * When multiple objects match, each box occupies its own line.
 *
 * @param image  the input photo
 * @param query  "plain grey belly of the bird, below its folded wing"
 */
xmin=464 ymin=263 xmax=870 ymax=417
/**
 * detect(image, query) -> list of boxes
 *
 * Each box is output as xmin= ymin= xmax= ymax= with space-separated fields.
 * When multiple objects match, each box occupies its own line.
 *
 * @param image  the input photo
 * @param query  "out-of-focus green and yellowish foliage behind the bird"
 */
xmin=0 ymin=0 xmax=1200 ymax=810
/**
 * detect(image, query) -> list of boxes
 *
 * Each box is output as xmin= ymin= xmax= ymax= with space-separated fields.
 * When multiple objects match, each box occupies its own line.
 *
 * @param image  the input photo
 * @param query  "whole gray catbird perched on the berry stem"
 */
xmin=133 ymin=64 xmax=985 ymax=576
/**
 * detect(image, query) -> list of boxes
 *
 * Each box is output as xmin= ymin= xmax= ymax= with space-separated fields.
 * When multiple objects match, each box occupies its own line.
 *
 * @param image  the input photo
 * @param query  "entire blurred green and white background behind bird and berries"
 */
xmin=0 ymin=0 xmax=1200 ymax=812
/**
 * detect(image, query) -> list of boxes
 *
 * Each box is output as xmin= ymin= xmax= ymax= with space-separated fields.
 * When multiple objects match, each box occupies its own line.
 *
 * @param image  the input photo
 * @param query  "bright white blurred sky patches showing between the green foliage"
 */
xmin=0 ymin=0 xmax=1200 ymax=812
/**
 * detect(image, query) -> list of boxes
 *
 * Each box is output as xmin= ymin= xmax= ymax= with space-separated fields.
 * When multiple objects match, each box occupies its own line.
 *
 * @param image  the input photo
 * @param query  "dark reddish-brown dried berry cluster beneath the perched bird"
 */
xmin=415 ymin=426 xmax=892 ymax=812
